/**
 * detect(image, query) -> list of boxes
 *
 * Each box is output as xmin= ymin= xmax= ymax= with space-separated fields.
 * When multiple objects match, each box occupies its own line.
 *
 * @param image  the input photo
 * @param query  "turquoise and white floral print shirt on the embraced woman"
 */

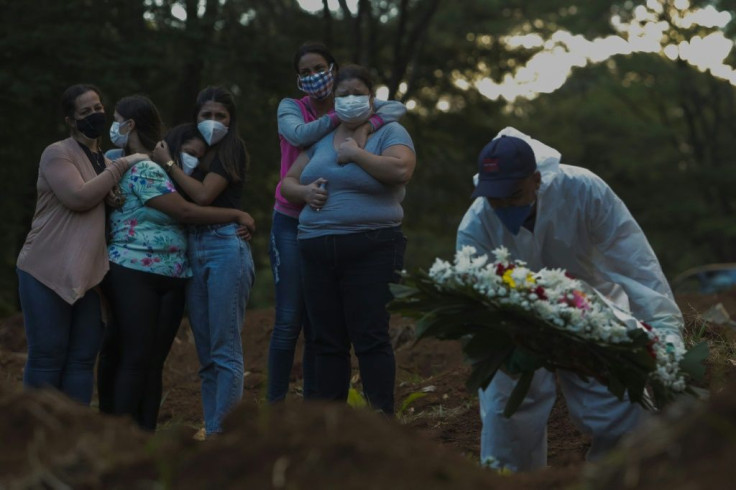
xmin=107 ymin=160 xmax=192 ymax=277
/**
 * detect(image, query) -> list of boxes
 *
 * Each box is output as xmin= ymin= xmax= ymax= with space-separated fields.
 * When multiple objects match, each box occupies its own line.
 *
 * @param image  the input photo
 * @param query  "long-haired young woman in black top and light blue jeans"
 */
xmin=153 ymin=87 xmax=255 ymax=436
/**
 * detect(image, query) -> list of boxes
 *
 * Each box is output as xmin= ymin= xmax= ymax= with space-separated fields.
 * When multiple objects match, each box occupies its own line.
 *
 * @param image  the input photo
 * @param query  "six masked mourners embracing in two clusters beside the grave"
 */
xmin=17 ymin=43 xmax=416 ymax=436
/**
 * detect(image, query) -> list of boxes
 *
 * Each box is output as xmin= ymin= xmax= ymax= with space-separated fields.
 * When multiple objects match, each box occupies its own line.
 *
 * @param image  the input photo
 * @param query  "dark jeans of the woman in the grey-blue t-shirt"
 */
xmin=299 ymin=227 xmax=406 ymax=414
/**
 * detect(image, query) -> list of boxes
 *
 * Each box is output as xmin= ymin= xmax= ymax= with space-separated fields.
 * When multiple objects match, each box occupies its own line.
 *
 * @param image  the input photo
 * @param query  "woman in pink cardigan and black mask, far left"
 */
xmin=16 ymin=84 xmax=146 ymax=404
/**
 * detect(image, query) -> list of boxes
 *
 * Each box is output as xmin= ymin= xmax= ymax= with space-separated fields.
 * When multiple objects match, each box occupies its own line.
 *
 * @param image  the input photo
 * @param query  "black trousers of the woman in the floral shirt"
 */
xmin=97 ymin=263 xmax=186 ymax=430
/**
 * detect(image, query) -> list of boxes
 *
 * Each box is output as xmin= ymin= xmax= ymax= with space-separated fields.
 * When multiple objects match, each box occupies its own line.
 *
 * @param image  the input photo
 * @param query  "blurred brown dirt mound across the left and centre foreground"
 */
xmin=0 ymin=390 xmax=577 ymax=490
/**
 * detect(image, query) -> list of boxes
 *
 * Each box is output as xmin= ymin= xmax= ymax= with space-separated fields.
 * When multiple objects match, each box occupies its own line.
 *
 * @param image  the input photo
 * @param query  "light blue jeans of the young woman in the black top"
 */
xmin=187 ymin=224 xmax=255 ymax=434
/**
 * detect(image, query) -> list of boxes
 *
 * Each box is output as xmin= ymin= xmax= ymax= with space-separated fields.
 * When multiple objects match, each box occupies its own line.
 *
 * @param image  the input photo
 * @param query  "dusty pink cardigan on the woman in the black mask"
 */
xmin=16 ymin=138 xmax=128 ymax=304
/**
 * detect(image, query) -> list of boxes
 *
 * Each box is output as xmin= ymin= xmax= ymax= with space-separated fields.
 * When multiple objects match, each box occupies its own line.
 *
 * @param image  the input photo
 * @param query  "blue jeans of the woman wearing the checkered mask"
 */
xmin=266 ymin=211 xmax=315 ymax=403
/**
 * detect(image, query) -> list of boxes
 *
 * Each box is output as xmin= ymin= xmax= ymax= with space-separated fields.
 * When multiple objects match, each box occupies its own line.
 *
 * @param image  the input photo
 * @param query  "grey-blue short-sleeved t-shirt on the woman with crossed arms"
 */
xmin=299 ymin=122 xmax=414 ymax=239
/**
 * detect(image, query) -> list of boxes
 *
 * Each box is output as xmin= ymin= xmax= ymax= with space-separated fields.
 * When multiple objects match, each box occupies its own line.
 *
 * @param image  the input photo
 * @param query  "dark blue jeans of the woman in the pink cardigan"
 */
xmin=16 ymin=269 xmax=103 ymax=405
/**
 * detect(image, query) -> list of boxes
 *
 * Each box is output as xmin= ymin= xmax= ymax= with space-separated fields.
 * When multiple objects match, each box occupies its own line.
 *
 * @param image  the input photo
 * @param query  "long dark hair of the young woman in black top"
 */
xmin=194 ymin=86 xmax=250 ymax=182
